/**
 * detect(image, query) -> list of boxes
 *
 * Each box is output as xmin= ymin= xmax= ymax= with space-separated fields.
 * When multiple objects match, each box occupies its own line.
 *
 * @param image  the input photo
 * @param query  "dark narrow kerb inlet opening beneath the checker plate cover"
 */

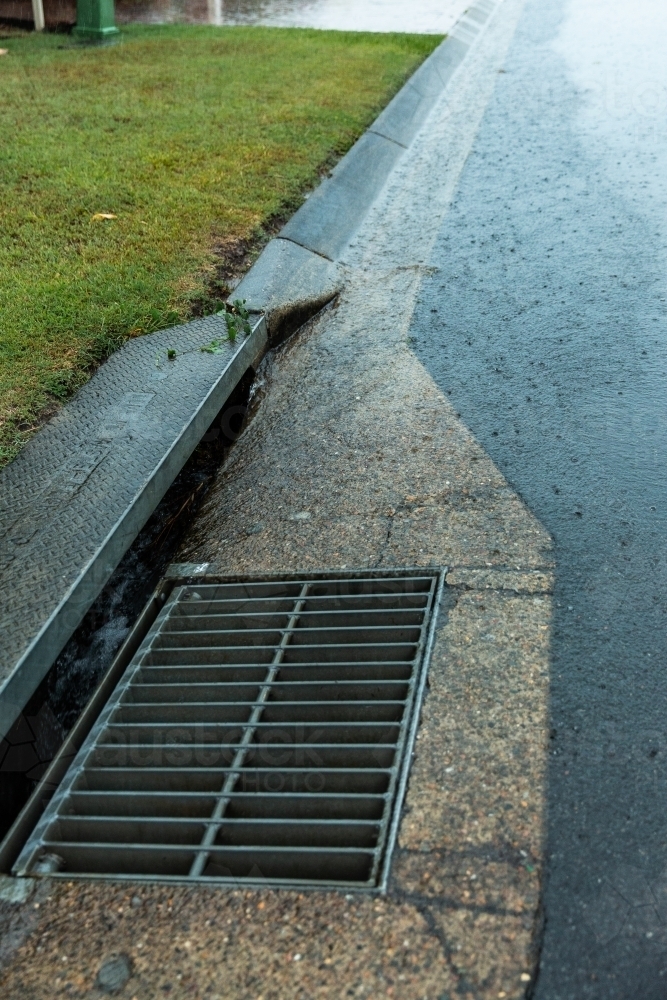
xmin=0 ymin=368 xmax=257 ymax=852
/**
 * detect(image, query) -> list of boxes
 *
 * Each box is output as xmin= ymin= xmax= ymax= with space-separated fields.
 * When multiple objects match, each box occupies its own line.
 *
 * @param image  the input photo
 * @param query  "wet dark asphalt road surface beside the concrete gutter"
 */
xmin=412 ymin=0 xmax=667 ymax=1000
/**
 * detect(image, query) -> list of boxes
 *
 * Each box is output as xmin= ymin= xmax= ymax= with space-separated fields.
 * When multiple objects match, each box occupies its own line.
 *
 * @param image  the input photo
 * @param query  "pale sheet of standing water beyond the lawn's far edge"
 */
xmin=116 ymin=0 xmax=469 ymax=34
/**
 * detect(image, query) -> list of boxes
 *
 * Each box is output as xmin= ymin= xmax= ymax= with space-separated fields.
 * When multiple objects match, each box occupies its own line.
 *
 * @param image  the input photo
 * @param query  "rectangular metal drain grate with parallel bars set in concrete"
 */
xmin=14 ymin=569 xmax=444 ymax=890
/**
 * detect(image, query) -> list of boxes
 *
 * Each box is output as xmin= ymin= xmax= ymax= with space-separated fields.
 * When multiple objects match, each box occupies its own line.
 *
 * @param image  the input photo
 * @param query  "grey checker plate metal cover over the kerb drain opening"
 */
xmin=0 ymin=316 xmax=266 ymax=737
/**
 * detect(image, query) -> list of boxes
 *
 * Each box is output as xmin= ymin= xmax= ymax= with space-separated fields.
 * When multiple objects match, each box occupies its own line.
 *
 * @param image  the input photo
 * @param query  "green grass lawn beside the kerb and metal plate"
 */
xmin=0 ymin=26 xmax=439 ymax=464
